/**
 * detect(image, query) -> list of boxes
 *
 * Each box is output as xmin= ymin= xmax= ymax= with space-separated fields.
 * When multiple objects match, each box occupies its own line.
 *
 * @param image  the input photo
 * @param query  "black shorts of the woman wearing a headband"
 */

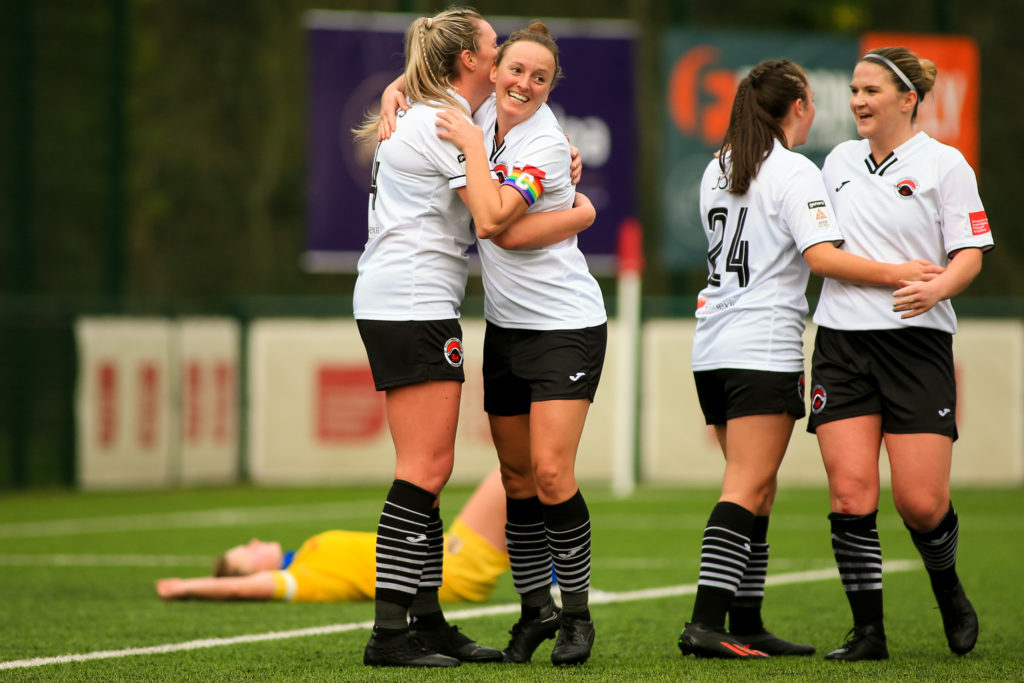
xmin=807 ymin=328 xmax=957 ymax=440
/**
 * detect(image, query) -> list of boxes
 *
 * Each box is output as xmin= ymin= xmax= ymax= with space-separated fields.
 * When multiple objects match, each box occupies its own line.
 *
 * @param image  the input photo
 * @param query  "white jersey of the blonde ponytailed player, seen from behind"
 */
xmin=352 ymin=95 xmax=473 ymax=321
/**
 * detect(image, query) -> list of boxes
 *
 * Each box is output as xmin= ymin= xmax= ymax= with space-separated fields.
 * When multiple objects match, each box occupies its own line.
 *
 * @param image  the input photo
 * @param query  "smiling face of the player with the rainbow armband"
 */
xmin=492 ymin=40 xmax=555 ymax=131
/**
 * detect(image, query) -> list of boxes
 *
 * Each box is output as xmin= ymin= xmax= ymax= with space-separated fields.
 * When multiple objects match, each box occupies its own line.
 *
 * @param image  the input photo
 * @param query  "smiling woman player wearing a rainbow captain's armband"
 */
xmin=438 ymin=22 xmax=607 ymax=665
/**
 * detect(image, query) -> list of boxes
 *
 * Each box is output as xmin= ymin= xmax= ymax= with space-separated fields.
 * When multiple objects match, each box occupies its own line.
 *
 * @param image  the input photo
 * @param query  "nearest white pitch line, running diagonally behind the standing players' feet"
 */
xmin=0 ymin=560 xmax=921 ymax=671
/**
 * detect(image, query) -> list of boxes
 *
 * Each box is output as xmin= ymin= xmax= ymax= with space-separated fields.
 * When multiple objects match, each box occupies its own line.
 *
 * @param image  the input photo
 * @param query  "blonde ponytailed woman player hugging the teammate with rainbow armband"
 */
xmin=353 ymin=8 xmax=593 ymax=667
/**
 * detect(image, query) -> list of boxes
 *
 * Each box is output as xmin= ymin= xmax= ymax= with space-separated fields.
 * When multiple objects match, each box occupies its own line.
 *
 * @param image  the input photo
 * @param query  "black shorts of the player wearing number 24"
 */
xmin=693 ymin=369 xmax=807 ymax=425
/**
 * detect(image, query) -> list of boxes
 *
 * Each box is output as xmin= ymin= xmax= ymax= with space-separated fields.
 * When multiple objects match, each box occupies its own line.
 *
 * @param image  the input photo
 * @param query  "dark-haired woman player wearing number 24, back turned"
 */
xmin=679 ymin=59 xmax=940 ymax=659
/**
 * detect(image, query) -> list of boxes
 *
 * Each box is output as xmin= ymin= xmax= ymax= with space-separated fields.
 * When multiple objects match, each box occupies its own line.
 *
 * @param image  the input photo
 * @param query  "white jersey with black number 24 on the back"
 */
xmin=692 ymin=140 xmax=843 ymax=372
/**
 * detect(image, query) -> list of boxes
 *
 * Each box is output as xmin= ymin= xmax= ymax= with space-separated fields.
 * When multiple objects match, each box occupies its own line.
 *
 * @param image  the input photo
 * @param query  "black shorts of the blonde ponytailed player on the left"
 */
xmin=355 ymin=319 xmax=466 ymax=391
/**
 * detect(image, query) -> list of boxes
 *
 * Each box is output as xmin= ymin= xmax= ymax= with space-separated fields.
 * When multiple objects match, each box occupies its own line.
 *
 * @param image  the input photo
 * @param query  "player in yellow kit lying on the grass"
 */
xmin=157 ymin=470 xmax=509 ymax=602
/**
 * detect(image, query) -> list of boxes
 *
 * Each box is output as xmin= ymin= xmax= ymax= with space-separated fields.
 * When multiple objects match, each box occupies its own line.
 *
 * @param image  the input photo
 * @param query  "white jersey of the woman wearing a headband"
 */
xmin=814 ymin=132 xmax=992 ymax=334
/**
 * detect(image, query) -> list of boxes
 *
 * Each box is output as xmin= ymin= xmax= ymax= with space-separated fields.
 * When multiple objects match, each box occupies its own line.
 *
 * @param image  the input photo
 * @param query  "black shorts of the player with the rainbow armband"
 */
xmin=483 ymin=323 xmax=608 ymax=416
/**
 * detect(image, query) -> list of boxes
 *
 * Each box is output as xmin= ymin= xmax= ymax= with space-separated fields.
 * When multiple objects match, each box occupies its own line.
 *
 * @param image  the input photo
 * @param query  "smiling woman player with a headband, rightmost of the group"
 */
xmin=808 ymin=47 xmax=992 ymax=661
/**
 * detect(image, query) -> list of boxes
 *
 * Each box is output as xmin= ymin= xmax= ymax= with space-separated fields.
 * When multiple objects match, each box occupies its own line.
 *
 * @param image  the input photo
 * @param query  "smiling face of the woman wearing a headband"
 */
xmin=850 ymin=61 xmax=916 ymax=151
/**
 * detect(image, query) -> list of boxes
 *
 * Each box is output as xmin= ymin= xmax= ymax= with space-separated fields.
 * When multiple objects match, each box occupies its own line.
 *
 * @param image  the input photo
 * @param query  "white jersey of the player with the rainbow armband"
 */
xmin=475 ymin=98 xmax=608 ymax=330
